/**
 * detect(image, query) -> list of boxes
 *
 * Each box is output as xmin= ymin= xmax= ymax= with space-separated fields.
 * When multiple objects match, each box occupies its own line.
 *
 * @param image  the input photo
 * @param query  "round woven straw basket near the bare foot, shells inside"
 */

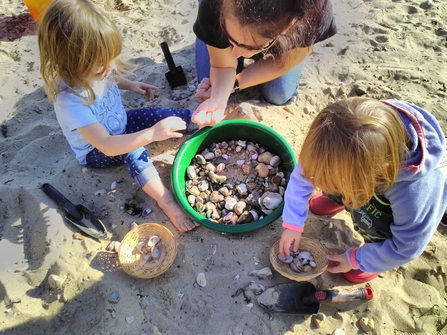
xmin=118 ymin=223 xmax=177 ymax=279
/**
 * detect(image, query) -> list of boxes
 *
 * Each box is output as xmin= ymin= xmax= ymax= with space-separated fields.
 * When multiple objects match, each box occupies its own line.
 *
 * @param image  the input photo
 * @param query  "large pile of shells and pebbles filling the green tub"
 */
xmin=186 ymin=141 xmax=287 ymax=224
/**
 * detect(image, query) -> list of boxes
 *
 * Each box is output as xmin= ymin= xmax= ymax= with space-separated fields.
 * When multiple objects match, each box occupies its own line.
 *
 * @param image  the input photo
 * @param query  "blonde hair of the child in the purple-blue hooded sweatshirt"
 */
xmin=299 ymin=98 xmax=408 ymax=208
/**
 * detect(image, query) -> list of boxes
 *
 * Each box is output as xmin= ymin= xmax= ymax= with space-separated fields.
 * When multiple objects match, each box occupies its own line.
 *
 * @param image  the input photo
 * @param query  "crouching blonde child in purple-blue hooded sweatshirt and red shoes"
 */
xmin=280 ymin=98 xmax=447 ymax=283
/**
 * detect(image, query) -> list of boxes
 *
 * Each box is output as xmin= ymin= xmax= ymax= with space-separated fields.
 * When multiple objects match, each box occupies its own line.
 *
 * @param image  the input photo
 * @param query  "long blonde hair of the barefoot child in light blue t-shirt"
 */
xmin=38 ymin=0 xmax=126 ymax=105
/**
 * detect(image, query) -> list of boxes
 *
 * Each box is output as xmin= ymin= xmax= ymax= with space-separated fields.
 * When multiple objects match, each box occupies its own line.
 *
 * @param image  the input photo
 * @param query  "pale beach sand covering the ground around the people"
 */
xmin=0 ymin=0 xmax=447 ymax=335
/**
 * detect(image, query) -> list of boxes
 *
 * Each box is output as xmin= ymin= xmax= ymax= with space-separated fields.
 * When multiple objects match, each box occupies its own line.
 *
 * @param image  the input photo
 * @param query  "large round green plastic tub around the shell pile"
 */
xmin=171 ymin=120 xmax=297 ymax=233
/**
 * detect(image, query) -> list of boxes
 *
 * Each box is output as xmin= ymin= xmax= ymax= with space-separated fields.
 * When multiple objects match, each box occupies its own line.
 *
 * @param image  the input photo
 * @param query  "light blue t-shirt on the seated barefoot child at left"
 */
xmin=54 ymin=78 xmax=127 ymax=165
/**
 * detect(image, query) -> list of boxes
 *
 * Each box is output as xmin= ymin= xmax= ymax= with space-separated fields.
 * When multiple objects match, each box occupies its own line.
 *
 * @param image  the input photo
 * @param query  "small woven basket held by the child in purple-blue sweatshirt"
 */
xmin=270 ymin=236 xmax=328 ymax=281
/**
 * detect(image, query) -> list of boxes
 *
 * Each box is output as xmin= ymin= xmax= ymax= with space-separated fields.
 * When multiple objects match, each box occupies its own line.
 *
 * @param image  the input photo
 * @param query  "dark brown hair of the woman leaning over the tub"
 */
xmin=220 ymin=0 xmax=327 ymax=56
